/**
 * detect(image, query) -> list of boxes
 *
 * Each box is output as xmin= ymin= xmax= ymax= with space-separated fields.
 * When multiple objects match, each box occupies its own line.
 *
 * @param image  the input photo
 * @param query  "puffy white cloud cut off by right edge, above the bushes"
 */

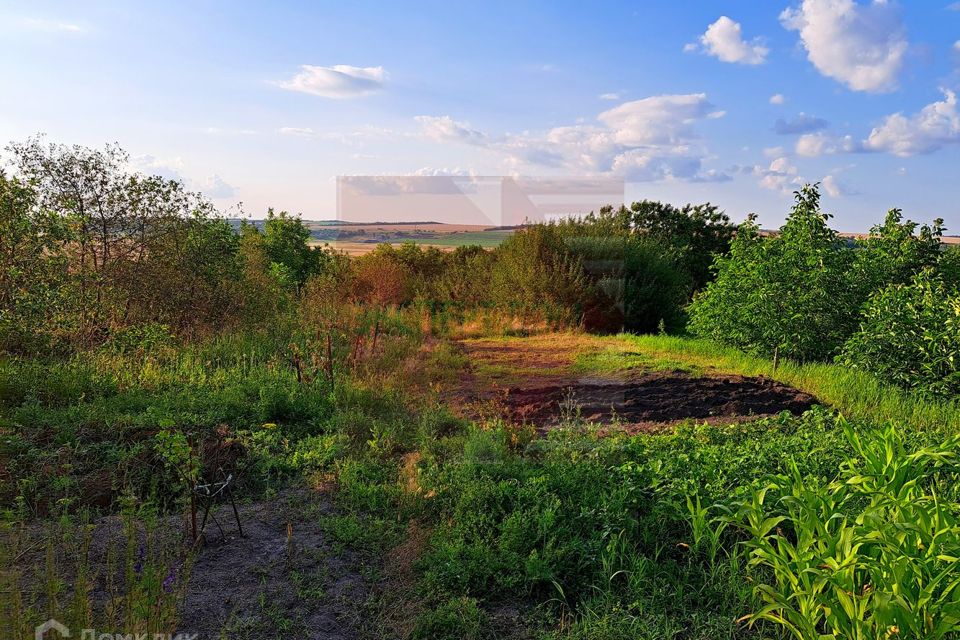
xmin=864 ymin=89 xmax=960 ymax=156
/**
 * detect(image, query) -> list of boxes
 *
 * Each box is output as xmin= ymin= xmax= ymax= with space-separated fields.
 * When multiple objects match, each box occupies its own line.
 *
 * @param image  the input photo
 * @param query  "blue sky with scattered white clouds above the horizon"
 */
xmin=0 ymin=0 xmax=960 ymax=234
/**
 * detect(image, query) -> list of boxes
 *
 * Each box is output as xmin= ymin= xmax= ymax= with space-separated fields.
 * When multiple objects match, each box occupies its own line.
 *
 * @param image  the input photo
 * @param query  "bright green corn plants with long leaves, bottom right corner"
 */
xmin=730 ymin=422 xmax=960 ymax=640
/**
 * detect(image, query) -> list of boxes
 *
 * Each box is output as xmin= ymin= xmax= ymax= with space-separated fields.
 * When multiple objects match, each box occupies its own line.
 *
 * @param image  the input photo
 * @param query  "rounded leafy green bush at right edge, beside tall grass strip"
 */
xmin=839 ymin=270 xmax=960 ymax=396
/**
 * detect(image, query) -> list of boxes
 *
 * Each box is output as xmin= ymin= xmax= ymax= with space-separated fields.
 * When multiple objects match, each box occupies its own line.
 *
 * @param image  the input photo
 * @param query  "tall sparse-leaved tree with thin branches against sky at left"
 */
xmin=8 ymin=137 xmax=213 ymax=341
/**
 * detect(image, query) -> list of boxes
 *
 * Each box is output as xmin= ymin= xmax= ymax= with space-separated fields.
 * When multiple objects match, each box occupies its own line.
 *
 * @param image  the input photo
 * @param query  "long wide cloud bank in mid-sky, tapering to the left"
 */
xmin=417 ymin=93 xmax=730 ymax=182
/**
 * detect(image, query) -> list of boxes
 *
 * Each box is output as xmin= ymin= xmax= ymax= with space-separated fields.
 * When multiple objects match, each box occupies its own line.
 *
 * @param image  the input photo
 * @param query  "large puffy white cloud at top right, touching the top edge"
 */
xmin=780 ymin=0 xmax=908 ymax=92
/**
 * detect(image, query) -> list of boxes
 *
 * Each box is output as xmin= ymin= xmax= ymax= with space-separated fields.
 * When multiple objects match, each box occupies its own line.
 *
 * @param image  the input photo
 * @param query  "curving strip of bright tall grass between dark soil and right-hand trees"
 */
xmin=614 ymin=335 xmax=960 ymax=432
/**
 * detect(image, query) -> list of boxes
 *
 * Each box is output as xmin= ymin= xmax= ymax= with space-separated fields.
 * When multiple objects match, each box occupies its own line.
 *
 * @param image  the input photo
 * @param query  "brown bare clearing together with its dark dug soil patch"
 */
xmin=457 ymin=334 xmax=817 ymax=431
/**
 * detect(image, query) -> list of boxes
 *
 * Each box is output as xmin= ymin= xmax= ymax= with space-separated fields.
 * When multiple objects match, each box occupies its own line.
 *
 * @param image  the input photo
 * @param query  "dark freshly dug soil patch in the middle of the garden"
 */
xmin=505 ymin=372 xmax=817 ymax=428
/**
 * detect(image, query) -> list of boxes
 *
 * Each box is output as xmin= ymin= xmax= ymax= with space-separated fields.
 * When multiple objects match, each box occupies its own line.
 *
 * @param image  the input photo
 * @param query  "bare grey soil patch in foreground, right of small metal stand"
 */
xmin=179 ymin=491 xmax=368 ymax=640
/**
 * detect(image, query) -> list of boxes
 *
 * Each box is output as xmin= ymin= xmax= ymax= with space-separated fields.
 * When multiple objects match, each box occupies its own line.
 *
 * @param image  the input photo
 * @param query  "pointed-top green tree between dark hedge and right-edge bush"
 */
xmin=690 ymin=185 xmax=858 ymax=361
